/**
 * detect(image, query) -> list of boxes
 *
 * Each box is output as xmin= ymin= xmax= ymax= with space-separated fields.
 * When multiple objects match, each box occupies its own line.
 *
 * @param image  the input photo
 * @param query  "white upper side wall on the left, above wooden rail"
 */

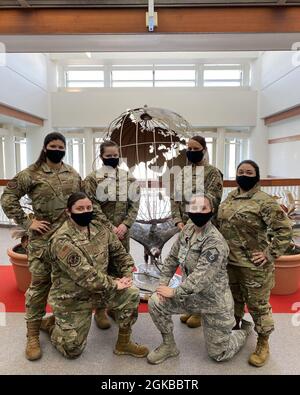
xmin=0 ymin=54 xmax=49 ymax=119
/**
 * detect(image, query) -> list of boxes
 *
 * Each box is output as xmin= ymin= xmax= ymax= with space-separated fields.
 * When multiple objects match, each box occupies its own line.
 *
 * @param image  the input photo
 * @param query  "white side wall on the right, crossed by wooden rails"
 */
xmin=259 ymin=51 xmax=300 ymax=178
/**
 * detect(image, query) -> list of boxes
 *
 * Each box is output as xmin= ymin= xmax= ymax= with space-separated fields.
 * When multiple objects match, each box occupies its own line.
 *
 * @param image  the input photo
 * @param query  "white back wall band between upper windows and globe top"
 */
xmin=51 ymin=88 xmax=257 ymax=127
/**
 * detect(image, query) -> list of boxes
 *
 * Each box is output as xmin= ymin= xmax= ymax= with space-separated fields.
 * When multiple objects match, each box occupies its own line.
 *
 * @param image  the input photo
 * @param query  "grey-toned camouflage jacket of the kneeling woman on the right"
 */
xmin=160 ymin=222 xmax=229 ymax=302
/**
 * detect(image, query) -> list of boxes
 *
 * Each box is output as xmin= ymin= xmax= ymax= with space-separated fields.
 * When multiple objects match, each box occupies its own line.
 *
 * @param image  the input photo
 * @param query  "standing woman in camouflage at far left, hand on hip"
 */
xmin=1 ymin=133 xmax=81 ymax=361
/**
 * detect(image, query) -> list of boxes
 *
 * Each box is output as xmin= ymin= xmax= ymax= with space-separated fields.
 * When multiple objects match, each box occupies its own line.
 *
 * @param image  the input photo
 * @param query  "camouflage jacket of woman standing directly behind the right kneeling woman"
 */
xmin=171 ymin=164 xmax=223 ymax=225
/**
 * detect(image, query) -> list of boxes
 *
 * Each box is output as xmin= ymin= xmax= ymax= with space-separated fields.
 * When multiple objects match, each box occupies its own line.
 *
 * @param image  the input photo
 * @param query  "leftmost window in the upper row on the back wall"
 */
xmin=66 ymin=67 xmax=104 ymax=88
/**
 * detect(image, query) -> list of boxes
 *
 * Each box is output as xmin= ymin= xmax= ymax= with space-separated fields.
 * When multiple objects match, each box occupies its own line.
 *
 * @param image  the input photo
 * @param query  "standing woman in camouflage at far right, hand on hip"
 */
xmin=218 ymin=160 xmax=292 ymax=367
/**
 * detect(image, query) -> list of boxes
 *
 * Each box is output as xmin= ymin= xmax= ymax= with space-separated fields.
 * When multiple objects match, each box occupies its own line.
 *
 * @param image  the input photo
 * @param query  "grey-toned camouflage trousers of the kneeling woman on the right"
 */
xmin=149 ymin=289 xmax=246 ymax=362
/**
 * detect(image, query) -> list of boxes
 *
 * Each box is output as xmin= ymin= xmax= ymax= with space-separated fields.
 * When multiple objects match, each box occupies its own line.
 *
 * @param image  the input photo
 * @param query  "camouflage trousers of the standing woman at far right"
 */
xmin=227 ymin=264 xmax=275 ymax=336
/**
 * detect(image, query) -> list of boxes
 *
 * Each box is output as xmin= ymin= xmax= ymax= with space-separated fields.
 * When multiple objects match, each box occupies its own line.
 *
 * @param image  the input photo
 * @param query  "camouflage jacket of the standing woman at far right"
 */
xmin=218 ymin=184 xmax=292 ymax=268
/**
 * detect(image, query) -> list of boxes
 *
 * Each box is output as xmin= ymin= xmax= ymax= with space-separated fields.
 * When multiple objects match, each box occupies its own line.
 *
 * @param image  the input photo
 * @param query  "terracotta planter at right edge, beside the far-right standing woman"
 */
xmin=271 ymin=254 xmax=300 ymax=295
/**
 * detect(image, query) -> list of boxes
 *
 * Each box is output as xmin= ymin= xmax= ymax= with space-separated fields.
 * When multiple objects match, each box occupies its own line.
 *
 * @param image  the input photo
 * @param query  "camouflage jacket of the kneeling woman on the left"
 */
xmin=49 ymin=219 xmax=134 ymax=308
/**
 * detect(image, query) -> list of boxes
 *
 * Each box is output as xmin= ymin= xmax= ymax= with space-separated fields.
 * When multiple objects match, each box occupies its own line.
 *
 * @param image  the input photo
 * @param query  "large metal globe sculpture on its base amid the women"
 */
xmin=105 ymin=106 xmax=192 ymax=299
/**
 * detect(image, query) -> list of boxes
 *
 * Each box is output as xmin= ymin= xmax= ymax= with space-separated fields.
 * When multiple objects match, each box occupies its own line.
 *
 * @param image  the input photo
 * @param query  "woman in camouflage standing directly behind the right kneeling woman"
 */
xmin=171 ymin=136 xmax=223 ymax=328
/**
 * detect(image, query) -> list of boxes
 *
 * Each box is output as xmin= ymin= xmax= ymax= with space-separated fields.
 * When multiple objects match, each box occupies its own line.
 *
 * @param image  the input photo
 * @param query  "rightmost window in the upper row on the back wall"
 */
xmin=203 ymin=64 xmax=243 ymax=87
